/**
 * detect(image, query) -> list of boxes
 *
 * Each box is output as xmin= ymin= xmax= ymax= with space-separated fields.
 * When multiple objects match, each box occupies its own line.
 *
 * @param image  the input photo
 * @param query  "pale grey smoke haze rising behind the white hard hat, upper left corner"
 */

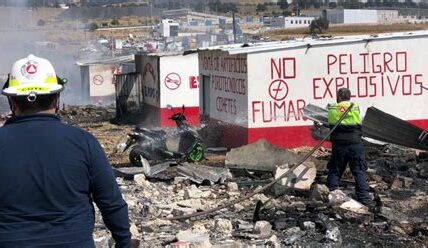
xmin=0 ymin=0 xmax=80 ymax=112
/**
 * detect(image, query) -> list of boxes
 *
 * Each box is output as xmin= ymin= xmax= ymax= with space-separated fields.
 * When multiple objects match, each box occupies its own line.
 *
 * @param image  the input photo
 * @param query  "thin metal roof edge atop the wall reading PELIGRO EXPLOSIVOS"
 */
xmin=196 ymin=30 xmax=428 ymax=55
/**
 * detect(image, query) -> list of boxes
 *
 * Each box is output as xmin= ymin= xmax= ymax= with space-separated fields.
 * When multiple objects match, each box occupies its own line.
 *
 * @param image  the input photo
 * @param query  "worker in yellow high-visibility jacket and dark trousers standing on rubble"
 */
xmin=327 ymin=88 xmax=372 ymax=206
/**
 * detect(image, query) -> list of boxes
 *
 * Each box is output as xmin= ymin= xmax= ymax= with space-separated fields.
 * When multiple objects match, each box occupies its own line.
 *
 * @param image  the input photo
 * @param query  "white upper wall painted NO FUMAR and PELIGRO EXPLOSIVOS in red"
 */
xmin=247 ymin=36 xmax=428 ymax=128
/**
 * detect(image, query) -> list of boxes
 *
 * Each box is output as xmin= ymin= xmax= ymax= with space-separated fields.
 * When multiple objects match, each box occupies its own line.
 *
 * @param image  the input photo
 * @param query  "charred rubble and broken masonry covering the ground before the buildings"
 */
xmin=84 ymin=124 xmax=428 ymax=247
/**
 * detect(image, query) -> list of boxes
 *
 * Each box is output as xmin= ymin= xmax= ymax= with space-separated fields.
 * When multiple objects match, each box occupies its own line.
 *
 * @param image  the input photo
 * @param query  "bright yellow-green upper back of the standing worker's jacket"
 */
xmin=328 ymin=101 xmax=361 ymax=125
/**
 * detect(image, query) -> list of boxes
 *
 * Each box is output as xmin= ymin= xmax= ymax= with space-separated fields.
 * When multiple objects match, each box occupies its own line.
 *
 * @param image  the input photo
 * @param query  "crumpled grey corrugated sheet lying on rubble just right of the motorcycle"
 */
xmin=177 ymin=163 xmax=229 ymax=184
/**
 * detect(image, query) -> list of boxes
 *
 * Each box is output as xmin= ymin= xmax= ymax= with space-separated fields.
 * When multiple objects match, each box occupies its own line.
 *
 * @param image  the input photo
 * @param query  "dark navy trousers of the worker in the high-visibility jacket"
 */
xmin=327 ymin=143 xmax=370 ymax=204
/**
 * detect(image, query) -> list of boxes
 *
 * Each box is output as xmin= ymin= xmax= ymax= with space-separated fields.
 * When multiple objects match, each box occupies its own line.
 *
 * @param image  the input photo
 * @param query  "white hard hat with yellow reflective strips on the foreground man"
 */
xmin=2 ymin=54 xmax=66 ymax=96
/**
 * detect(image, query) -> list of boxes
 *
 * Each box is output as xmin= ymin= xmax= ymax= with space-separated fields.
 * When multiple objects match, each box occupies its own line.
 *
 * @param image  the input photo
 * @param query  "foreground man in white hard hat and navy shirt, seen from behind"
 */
xmin=0 ymin=55 xmax=131 ymax=248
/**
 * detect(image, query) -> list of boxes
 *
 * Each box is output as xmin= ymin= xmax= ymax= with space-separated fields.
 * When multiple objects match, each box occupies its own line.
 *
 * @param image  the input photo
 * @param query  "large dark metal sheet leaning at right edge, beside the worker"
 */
xmin=363 ymin=107 xmax=428 ymax=150
